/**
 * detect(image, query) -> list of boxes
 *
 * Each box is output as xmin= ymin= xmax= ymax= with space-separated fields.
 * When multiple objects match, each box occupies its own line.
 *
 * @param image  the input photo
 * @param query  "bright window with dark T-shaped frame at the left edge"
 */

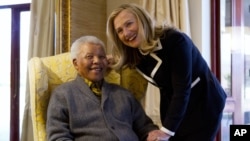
xmin=0 ymin=0 xmax=31 ymax=141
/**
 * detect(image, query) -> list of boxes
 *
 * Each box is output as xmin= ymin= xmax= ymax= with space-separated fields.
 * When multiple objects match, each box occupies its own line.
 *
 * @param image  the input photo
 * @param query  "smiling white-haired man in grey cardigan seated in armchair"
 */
xmin=46 ymin=36 xmax=165 ymax=141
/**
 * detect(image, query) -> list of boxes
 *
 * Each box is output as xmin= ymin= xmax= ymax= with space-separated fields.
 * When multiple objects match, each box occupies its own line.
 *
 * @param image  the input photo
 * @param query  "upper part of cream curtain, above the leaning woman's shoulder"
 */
xmin=139 ymin=0 xmax=191 ymax=36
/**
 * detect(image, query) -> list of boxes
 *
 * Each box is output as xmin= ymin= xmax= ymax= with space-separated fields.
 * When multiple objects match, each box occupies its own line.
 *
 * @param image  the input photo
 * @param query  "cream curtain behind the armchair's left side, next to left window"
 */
xmin=20 ymin=0 xmax=55 ymax=141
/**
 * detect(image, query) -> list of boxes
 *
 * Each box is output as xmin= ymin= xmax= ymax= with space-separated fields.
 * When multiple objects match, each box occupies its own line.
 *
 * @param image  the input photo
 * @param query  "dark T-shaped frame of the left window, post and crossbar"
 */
xmin=0 ymin=3 xmax=30 ymax=141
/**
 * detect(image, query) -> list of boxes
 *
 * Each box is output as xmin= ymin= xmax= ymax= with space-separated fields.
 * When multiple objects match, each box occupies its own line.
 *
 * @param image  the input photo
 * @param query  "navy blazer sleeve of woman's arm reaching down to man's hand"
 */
xmin=163 ymin=32 xmax=193 ymax=132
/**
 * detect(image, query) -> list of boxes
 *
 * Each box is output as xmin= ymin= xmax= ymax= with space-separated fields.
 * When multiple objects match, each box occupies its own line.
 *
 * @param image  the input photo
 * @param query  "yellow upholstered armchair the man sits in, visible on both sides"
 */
xmin=28 ymin=53 xmax=147 ymax=141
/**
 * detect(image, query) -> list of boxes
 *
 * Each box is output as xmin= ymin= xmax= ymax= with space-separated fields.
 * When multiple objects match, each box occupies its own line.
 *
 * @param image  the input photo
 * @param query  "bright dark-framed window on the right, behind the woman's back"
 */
xmin=212 ymin=0 xmax=250 ymax=141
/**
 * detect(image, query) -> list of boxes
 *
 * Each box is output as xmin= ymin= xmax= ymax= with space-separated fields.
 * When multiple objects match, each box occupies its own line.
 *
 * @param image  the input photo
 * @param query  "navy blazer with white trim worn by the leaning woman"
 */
xmin=137 ymin=29 xmax=226 ymax=135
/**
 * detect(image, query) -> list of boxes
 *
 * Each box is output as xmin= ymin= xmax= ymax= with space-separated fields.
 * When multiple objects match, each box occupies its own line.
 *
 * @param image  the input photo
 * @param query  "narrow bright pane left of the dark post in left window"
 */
xmin=0 ymin=9 xmax=11 ymax=141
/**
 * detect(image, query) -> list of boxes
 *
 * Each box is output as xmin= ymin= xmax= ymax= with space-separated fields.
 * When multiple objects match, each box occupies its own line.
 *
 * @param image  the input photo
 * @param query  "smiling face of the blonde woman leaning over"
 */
xmin=114 ymin=10 xmax=142 ymax=48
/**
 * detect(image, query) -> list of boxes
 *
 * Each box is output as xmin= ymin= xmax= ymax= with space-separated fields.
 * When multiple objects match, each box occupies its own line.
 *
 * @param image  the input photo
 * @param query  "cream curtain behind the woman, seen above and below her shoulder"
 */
xmin=139 ymin=0 xmax=191 ymax=126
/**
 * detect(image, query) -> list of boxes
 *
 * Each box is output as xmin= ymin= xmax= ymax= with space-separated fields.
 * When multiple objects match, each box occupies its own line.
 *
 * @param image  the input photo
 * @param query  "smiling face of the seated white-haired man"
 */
xmin=73 ymin=43 xmax=108 ymax=82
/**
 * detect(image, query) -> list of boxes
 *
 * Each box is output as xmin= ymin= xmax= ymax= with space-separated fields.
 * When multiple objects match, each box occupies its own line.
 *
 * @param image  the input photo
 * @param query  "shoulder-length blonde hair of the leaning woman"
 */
xmin=107 ymin=3 xmax=164 ymax=69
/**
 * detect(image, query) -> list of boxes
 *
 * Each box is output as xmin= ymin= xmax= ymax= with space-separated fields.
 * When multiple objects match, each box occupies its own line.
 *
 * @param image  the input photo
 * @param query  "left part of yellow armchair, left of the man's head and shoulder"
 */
xmin=28 ymin=53 xmax=77 ymax=141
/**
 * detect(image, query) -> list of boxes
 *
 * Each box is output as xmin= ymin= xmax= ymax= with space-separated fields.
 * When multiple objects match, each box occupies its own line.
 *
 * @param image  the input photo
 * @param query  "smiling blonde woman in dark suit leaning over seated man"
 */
xmin=107 ymin=4 xmax=226 ymax=141
